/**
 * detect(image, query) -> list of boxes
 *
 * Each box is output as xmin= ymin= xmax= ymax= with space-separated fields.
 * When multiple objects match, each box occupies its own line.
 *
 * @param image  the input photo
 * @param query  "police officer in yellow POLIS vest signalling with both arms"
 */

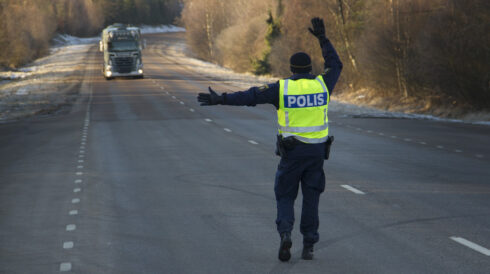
xmin=198 ymin=18 xmax=342 ymax=261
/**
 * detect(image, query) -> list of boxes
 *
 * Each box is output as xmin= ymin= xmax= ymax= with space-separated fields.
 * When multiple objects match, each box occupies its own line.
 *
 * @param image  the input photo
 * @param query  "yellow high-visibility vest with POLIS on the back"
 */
xmin=277 ymin=75 xmax=330 ymax=144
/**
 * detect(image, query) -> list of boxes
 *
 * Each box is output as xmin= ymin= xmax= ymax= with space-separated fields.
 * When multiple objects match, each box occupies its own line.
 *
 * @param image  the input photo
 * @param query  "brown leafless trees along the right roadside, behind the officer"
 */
xmin=182 ymin=0 xmax=490 ymax=110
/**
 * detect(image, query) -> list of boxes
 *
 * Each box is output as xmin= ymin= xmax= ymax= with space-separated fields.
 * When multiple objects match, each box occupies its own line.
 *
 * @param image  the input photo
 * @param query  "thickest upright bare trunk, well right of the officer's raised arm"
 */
xmin=390 ymin=0 xmax=408 ymax=98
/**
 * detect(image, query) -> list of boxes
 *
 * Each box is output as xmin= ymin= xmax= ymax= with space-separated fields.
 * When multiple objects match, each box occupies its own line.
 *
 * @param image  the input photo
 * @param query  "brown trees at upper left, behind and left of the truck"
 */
xmin=0 ymin=0 xmax=181 ymax=68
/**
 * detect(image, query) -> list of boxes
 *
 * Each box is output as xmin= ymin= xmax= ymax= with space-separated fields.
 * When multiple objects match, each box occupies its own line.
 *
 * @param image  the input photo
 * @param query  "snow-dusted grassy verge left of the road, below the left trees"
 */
xmin=0 ymin=41 xmax=94 ymax=122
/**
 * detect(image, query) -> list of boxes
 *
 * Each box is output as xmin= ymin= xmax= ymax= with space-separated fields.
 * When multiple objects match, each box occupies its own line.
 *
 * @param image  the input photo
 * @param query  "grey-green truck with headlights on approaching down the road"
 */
xmin=99 ymin=24 xmax=146 ymax=80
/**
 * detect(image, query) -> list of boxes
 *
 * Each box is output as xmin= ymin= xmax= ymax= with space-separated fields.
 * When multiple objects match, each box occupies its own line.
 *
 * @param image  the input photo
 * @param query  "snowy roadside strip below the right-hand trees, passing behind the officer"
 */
xmin=160 ymin=37 xmax=490 ymax=126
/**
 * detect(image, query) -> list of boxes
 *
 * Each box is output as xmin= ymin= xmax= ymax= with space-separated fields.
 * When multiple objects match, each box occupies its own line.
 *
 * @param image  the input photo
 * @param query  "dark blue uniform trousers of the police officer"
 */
xmin=274 ymin=155 xmax=325 ymax=244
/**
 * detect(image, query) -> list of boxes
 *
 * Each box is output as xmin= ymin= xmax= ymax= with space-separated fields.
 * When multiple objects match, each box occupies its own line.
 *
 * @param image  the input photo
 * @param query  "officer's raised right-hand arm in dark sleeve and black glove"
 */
xmin=309 ymin=17 xmax=343 ymax=95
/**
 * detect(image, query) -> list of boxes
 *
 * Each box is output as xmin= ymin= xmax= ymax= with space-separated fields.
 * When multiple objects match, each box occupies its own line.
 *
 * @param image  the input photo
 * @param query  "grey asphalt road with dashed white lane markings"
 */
xmin=0 ymin=34 xmax=490 ymax=273
